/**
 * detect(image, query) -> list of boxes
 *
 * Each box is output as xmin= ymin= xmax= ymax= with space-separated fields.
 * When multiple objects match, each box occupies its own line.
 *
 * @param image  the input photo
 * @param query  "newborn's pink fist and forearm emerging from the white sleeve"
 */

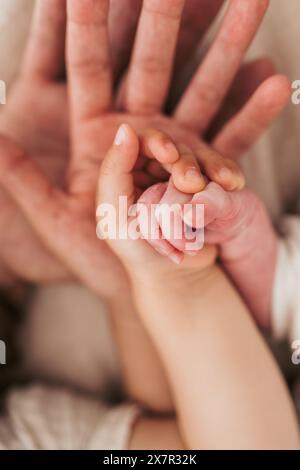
xmin=143 ymin=178 xmax=278 ymax=329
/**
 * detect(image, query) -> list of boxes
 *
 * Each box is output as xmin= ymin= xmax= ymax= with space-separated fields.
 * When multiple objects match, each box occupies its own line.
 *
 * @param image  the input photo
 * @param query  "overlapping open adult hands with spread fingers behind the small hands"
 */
xmin=0 ymin=0 xmax=287 ymax=295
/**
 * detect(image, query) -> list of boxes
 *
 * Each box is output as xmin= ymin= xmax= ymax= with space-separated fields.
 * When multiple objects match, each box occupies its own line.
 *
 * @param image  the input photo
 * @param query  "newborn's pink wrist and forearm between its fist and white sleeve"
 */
xmin=220 ymin=195 xmax=278 ymax=328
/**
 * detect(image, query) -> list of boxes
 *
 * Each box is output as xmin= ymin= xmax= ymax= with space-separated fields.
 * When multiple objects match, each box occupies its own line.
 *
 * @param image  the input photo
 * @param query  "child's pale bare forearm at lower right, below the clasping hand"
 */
xmin=131 ymin=267 xmax=298 ymax=449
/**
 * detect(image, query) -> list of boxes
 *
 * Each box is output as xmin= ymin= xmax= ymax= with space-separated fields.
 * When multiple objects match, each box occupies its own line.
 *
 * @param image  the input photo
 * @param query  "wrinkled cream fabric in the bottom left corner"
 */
xmin=0 ymin=385 xmax=139 ymax=450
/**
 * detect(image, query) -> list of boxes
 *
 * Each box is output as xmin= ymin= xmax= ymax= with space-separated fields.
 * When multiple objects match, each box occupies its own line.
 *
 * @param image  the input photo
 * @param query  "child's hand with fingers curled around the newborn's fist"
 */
xmin=97 ymin=125 xmax=215 ymax=280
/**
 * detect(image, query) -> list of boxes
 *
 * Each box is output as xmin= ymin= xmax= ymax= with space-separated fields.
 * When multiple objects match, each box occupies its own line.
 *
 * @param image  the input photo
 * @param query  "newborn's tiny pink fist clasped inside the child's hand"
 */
xmin=144 ymin=174 xmax=266 ymax=261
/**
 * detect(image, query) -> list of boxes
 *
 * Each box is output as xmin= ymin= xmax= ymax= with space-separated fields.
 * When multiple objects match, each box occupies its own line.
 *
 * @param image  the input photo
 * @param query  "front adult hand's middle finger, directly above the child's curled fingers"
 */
xmin=122 ymin=0 xmax=185 ymax=114
